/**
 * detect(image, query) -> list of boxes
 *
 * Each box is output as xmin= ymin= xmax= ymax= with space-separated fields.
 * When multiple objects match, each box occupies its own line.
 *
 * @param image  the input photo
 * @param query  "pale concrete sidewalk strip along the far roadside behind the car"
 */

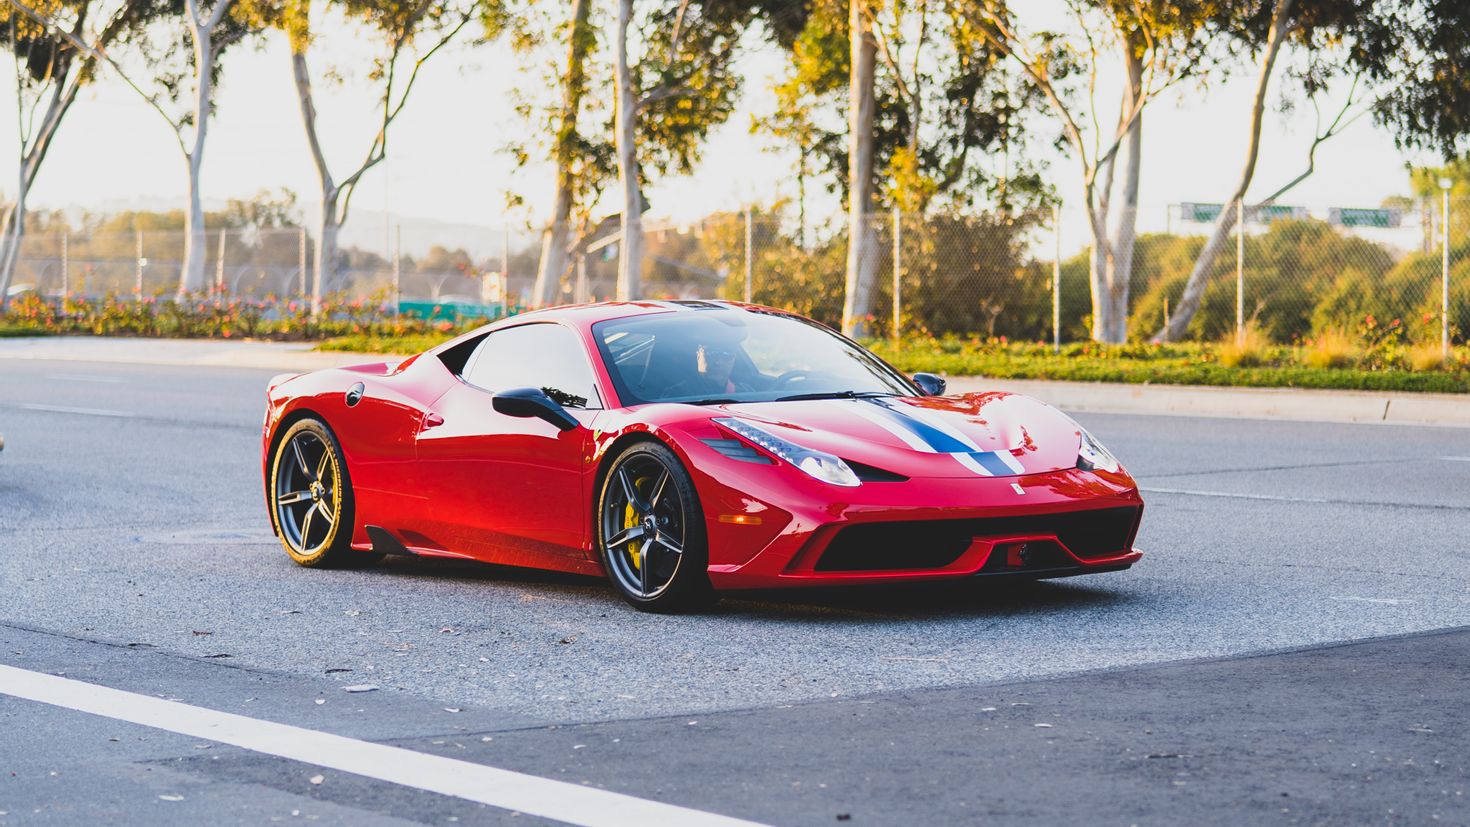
xmin=0 ymin=336 xmax=1470 ymax=427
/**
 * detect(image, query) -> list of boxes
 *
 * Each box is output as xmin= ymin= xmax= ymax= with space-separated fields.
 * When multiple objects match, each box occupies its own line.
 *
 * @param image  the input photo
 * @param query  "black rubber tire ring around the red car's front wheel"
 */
xmin=592 ymin=441 xmax=714 ymax=613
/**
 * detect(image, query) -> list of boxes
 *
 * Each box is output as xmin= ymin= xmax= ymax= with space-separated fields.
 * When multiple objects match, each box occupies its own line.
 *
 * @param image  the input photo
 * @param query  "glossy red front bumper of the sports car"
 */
xmin=693 ymin=469 xmax=1144 ymax=589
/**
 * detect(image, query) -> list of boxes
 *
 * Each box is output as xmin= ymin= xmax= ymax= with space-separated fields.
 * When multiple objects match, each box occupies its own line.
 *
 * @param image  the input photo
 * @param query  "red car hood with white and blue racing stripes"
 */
xmin=711 ymin=391 xmax=1082 ymax=479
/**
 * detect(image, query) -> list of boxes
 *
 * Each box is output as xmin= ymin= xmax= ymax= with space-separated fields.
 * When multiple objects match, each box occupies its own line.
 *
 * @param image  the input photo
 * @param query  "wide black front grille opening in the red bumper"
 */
xmin=816 ymin=507 xmax=1138 ymax=571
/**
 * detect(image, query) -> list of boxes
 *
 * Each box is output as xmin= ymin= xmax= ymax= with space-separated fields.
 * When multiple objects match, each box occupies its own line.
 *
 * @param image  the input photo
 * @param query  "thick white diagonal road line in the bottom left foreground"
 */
xmin=0 ymin=664 xmax=760 ymax=827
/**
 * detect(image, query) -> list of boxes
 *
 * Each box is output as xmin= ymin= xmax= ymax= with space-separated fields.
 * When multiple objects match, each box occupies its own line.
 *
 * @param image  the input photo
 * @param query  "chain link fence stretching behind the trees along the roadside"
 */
xmin=12 ymin=198 xmax=1470 ymax=344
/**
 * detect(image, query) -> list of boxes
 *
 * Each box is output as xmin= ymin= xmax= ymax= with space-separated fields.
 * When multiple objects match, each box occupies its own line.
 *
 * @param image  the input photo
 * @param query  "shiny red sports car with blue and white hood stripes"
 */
xmin=262 ymin=301 xmax=1144 ymax=611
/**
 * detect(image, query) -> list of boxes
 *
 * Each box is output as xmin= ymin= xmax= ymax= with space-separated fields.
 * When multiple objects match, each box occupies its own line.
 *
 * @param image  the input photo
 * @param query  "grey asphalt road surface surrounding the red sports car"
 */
xmin=0 ymin=361 xmax=1470 ymax=824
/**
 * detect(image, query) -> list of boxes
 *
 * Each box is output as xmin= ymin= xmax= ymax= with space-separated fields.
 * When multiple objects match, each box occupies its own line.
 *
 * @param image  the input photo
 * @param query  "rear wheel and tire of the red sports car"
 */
xmin=268 ymin=419 xmax=382 ymax=568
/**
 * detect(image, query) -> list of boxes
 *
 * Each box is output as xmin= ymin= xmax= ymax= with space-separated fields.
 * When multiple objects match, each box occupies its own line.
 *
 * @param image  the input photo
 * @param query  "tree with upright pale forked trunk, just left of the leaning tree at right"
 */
xmin=956 ymin=0 xmax=1217 ymax=342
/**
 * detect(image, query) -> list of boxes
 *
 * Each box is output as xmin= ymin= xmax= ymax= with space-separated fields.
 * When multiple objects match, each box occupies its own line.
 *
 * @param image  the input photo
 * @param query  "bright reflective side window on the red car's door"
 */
xmin=463 ymin=323 xmax=601 ymax=408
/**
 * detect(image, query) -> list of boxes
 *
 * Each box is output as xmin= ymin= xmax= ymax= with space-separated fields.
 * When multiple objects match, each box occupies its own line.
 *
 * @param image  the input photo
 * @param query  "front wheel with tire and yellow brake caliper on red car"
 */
xmin=597 ymin=442 xmax=719 ymax=613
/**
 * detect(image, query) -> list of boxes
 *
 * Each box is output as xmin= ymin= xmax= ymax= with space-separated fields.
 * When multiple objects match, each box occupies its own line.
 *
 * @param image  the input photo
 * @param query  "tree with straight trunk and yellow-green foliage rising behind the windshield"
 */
xmin=756 ymin=0 xmax=1042 ymax=333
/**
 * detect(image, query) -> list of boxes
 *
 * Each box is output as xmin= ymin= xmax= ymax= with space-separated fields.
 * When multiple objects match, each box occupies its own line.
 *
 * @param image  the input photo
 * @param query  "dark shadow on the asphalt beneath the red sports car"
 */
xmin=367 ymin=557 xmax=1141 ymax=623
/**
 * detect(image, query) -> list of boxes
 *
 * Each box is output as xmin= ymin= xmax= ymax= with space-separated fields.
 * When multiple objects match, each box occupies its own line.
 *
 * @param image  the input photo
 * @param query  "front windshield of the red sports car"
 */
xmin=592 ymin=308 xmax=914 ymax=405
